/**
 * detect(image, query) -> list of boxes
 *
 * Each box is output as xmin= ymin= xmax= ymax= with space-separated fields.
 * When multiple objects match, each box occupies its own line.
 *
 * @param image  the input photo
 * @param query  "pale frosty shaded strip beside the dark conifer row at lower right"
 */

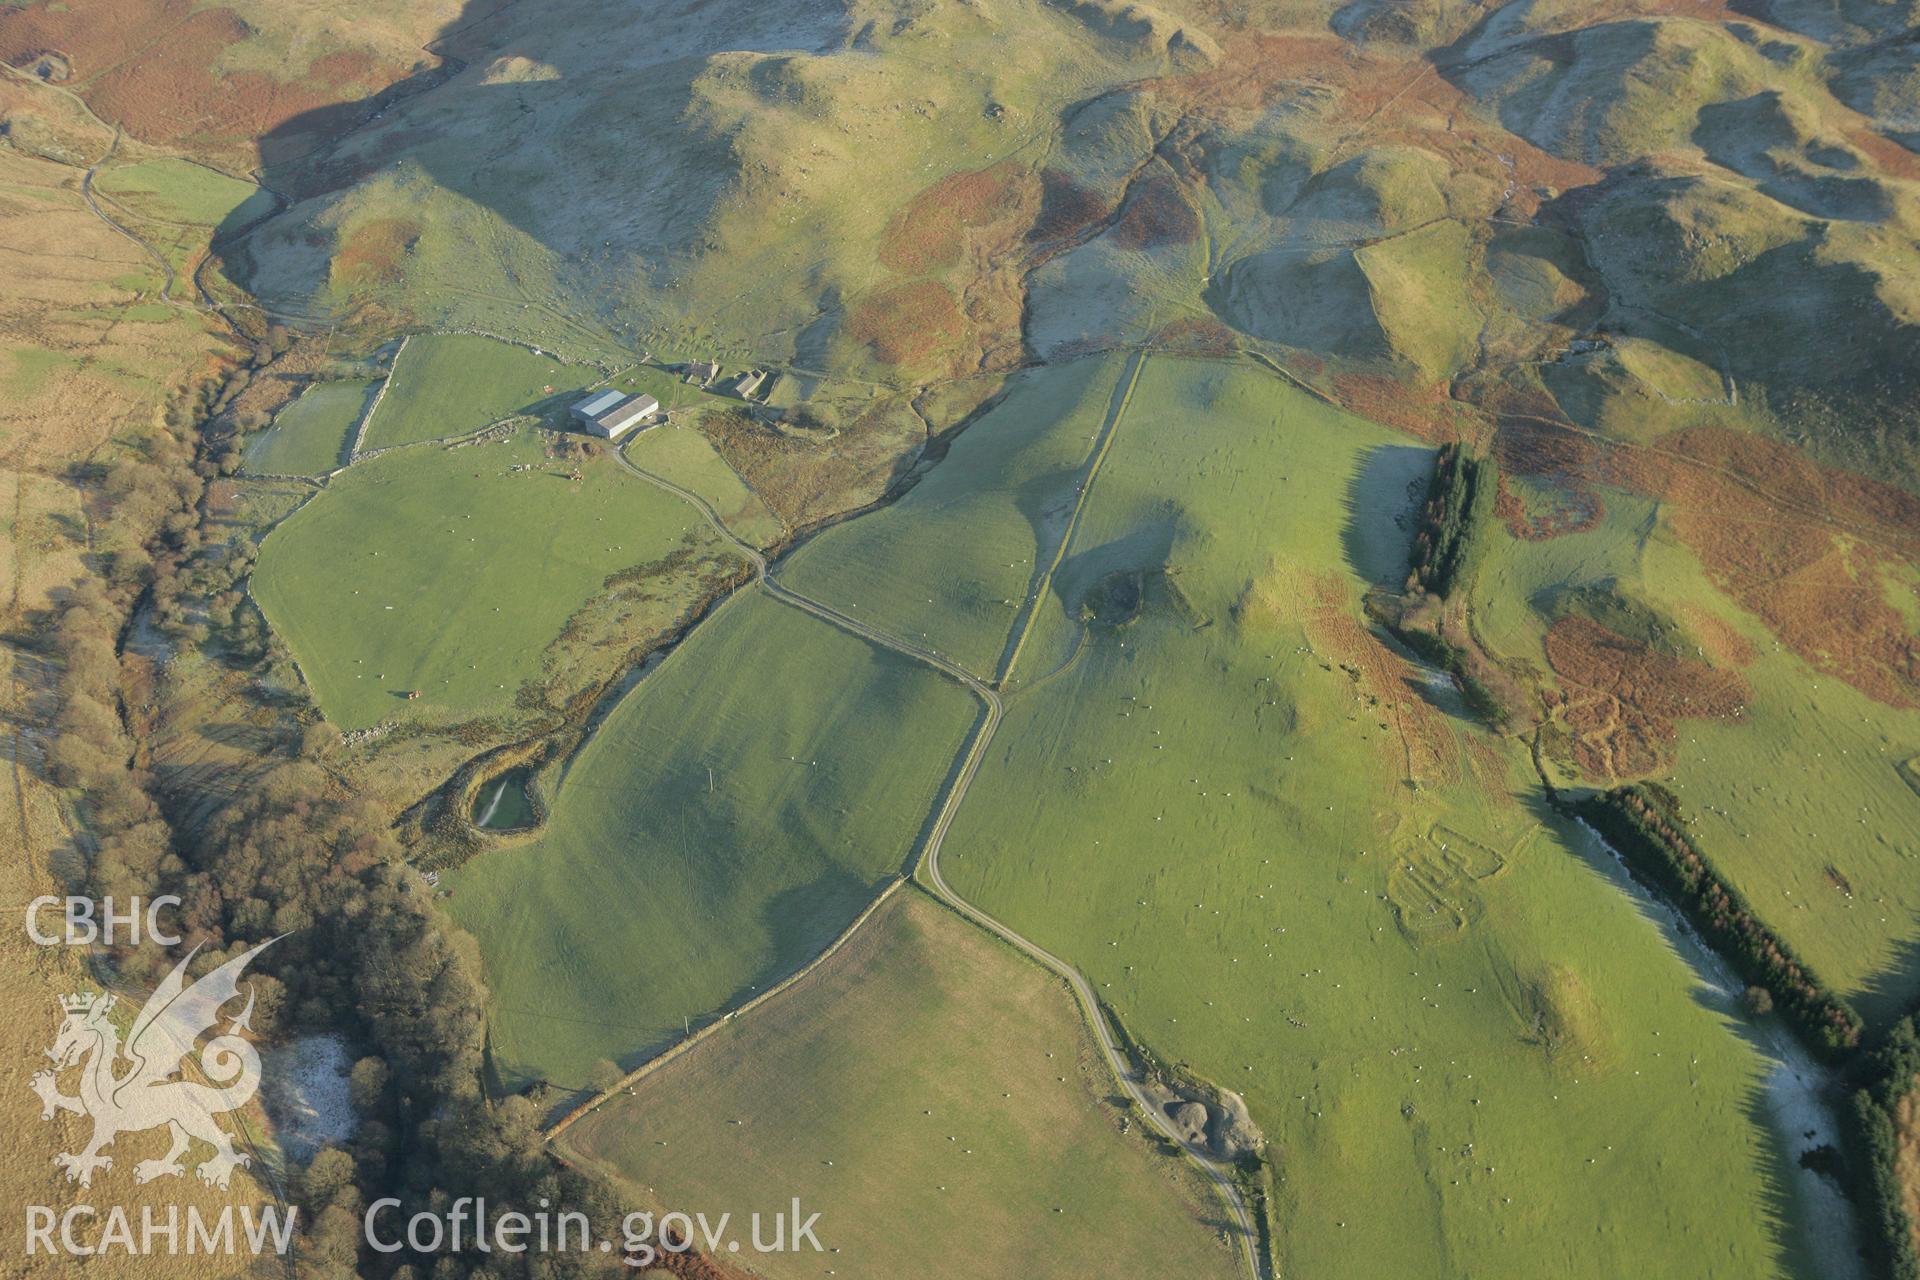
xmin=1578 ymin=821 xmax=1866 ymax=1280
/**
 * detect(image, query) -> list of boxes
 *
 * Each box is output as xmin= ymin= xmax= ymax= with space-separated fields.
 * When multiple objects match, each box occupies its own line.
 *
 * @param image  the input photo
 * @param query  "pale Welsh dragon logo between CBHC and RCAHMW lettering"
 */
xmin=33 ymin=938 xmax=278 ymax=1188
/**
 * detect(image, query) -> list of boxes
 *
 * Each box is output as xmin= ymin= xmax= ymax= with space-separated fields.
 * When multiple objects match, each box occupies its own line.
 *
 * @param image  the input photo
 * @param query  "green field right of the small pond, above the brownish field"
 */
xmin=449 ymin=593 xmax=975 ymax=1086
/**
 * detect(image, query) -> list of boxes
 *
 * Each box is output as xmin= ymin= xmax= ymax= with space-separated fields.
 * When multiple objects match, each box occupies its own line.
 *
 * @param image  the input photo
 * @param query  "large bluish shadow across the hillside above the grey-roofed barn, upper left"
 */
xmin=243 ymin=0 xmax=852 ymax=310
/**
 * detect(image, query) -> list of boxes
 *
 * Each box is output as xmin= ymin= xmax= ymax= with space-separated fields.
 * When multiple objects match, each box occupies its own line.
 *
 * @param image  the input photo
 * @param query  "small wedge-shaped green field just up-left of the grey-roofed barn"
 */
xmin=363 ymin=334 xmax=599 ymax=449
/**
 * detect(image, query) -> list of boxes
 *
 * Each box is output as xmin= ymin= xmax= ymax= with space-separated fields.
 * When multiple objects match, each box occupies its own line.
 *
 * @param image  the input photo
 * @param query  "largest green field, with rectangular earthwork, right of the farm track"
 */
xmin=943 ymin=359 xmax=1827 ymax=1276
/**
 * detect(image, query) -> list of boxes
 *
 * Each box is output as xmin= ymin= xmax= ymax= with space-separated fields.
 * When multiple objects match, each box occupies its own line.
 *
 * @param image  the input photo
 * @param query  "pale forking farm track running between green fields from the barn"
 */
xmin=612 ymin=351 xmax=1271 ymax=1280
